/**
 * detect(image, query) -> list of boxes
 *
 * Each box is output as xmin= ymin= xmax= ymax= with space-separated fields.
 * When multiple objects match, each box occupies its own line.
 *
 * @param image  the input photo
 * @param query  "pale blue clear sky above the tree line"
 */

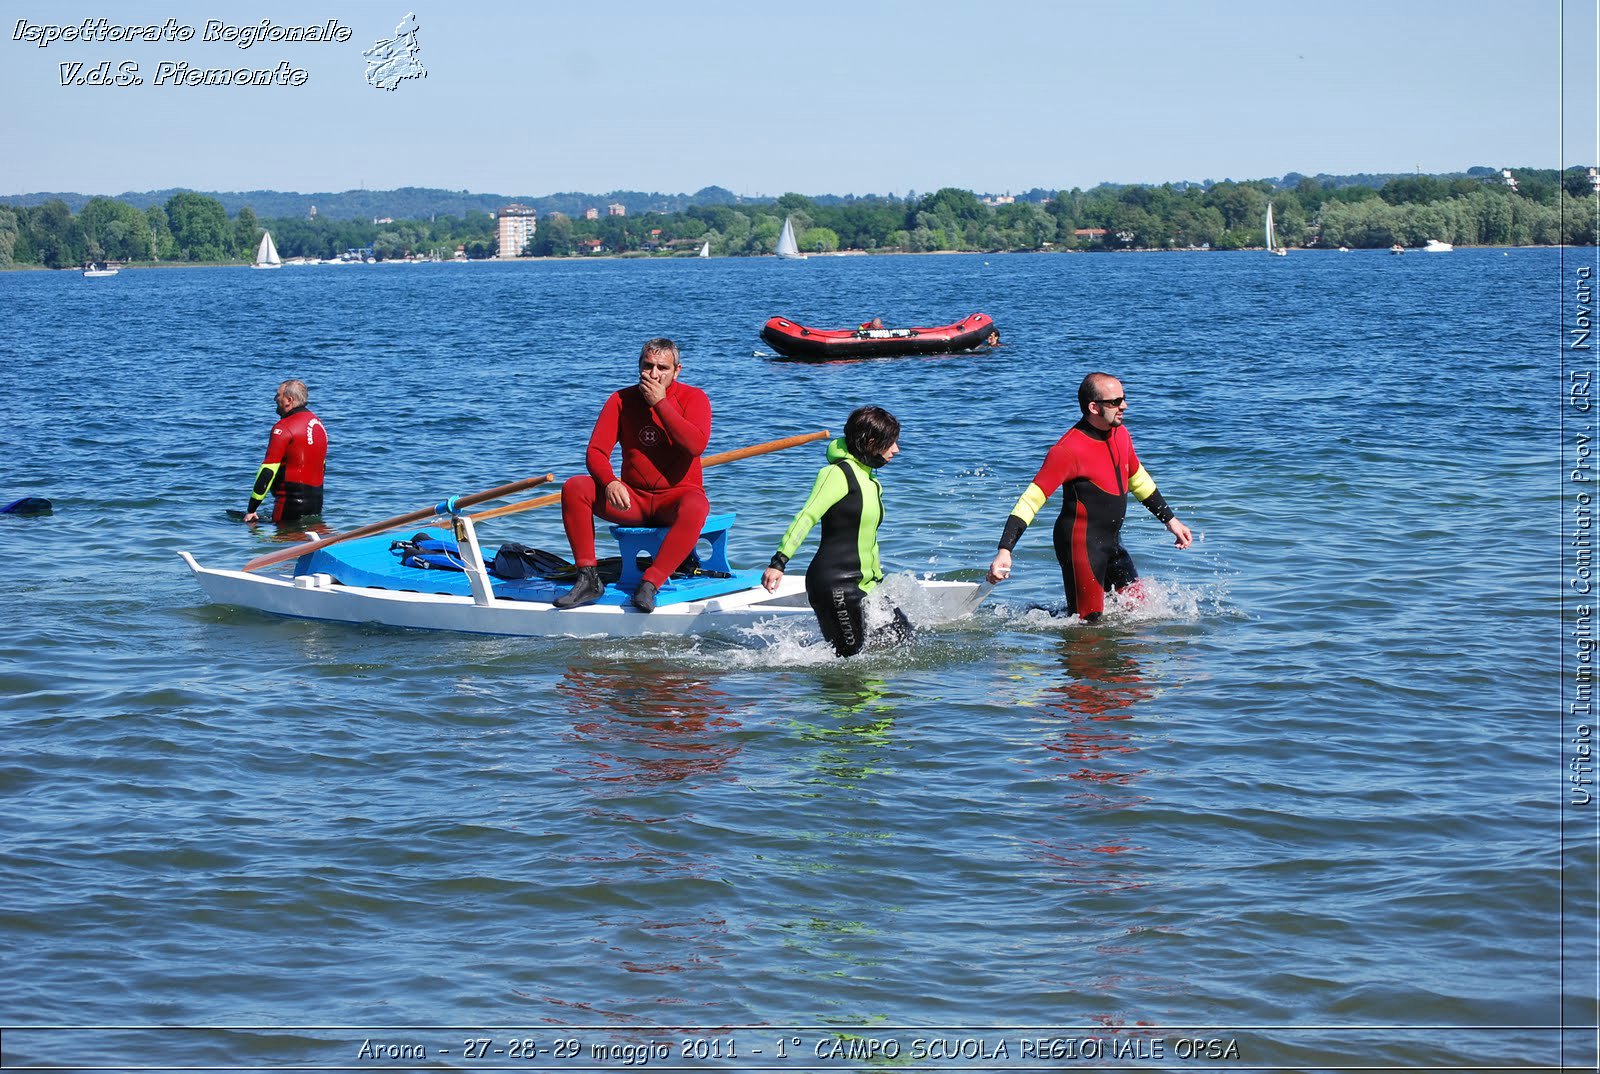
xmin=0 ymin=0 xmax=1600 ymax=197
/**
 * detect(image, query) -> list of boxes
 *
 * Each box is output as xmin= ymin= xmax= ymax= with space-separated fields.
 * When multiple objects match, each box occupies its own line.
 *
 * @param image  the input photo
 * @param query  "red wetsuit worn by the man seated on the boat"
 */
xmin=562 ymin=381 xmax=710 ymax=589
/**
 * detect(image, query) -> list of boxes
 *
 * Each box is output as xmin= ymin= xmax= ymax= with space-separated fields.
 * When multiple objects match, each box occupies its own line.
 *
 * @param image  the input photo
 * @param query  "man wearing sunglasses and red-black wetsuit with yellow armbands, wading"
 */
xmin=989 ymin=373 xmax=1194 ymax=621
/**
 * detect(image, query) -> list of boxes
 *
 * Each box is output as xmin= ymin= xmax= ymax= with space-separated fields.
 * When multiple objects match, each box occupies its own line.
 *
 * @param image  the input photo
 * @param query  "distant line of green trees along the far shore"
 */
xmin=0 ymin=170 xmax=1600 ymax=267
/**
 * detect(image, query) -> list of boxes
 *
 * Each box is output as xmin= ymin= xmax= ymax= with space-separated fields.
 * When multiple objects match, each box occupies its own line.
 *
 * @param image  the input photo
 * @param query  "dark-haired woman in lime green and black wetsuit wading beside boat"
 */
xmin=762 ymin=407 xmax=910 ymax=656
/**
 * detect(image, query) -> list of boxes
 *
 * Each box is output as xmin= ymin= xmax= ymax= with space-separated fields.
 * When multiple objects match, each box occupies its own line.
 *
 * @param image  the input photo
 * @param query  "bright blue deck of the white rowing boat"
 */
xmin=294 ymin=528 xmax=762 ymax=607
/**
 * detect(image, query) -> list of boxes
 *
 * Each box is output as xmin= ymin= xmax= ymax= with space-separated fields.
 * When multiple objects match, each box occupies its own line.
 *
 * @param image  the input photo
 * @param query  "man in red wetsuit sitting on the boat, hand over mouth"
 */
xmin=555 ymin=339 xmax=710 ymax=611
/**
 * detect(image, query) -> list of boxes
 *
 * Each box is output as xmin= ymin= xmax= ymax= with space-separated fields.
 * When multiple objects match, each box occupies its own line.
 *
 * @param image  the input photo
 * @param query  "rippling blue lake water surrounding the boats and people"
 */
xmin=0 ymin=250 xmax=1595 ymax=1069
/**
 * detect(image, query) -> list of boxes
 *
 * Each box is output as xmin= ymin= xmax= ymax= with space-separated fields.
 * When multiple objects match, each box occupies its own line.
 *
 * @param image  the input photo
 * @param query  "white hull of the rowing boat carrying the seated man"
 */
xmin=179 ymin=552 xmax=989 ymax=637
